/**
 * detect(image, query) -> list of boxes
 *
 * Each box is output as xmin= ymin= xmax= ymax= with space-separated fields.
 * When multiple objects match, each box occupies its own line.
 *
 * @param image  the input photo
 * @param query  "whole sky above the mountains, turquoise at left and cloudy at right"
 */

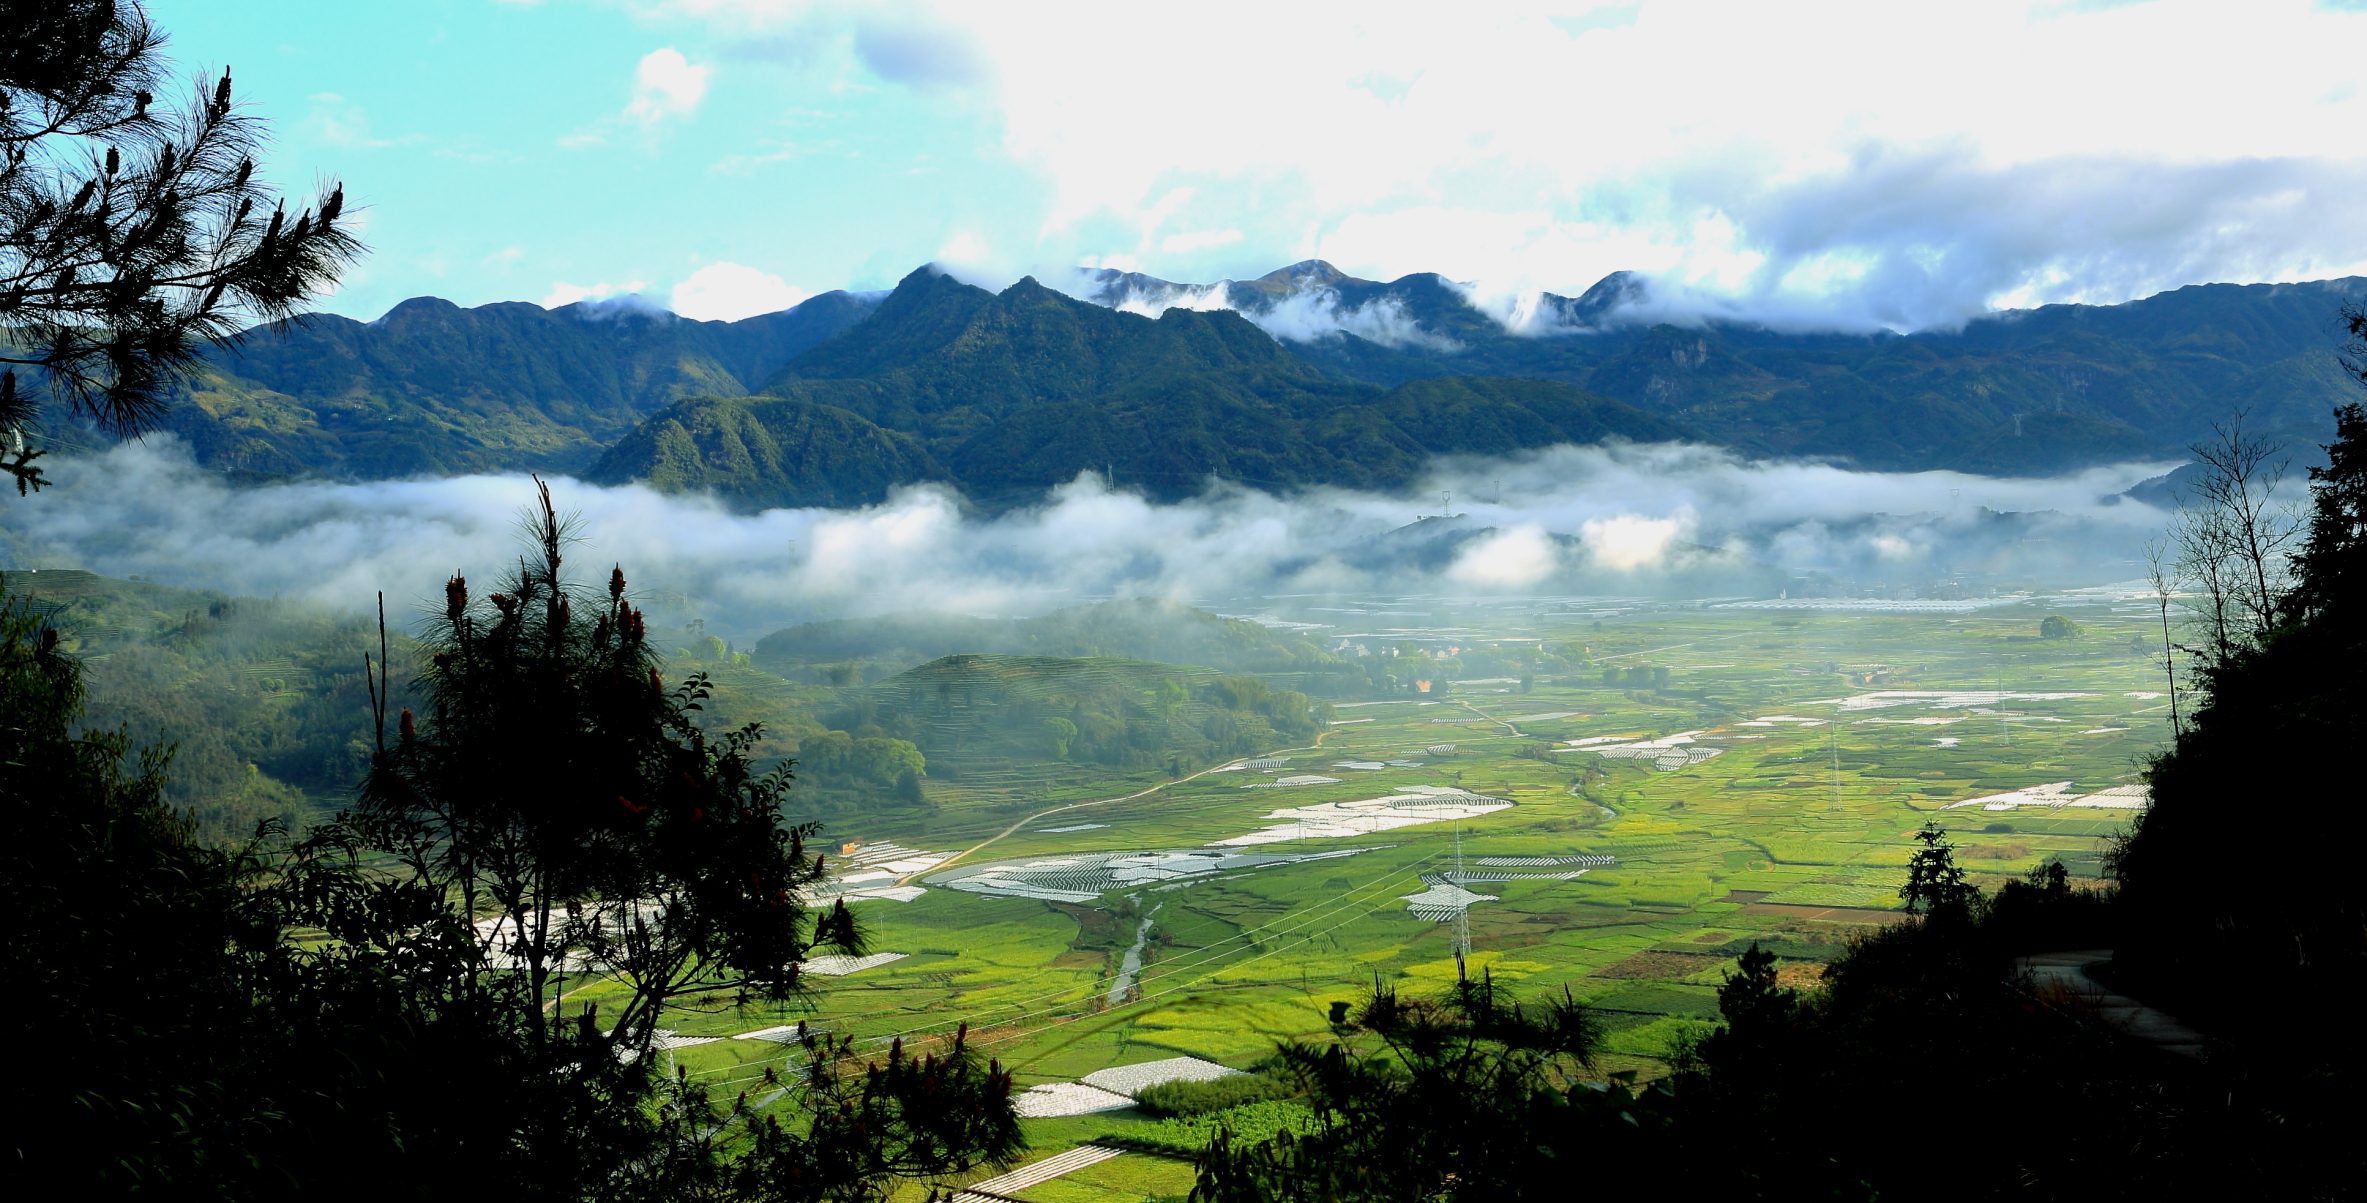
xmin=149 ymin=0 xmax=2367 ymax=329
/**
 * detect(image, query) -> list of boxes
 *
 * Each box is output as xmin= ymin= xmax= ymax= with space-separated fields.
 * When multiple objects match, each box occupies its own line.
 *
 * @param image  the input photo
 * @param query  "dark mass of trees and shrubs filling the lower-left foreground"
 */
xmin=0 ymin=485 xmax=1023 ymax=1203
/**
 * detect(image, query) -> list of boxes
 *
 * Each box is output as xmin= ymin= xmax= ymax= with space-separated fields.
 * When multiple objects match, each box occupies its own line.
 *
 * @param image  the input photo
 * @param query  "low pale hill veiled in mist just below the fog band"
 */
xmin=753 ymin=599 xmax=1340 ymax=677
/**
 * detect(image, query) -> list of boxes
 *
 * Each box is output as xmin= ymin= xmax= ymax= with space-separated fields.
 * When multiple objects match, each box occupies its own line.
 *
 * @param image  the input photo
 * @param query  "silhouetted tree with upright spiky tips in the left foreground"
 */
xmin=291 ymin=488 xmax=1020 ymax=1201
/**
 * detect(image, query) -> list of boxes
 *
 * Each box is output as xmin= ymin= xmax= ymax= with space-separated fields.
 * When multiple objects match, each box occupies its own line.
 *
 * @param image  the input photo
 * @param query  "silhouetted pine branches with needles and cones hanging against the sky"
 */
xmin=0 ymin=0 xmax=362 ymax=493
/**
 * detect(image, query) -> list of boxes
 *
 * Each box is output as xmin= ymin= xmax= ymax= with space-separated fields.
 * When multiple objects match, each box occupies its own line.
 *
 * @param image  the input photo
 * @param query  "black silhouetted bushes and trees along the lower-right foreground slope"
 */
xmin=1195 ymin=400 xmax=2367 ymax=1203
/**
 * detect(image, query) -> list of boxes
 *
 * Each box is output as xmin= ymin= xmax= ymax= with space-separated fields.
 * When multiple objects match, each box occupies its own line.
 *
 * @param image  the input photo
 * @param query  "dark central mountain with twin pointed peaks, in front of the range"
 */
xmin=592 ymin=270 xmax=1690 ymax=507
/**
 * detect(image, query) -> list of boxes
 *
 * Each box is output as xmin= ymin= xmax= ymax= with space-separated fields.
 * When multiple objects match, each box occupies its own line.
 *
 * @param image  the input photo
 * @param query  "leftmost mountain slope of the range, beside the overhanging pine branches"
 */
xmin=166 ymin=294 xmax=871 ymax=478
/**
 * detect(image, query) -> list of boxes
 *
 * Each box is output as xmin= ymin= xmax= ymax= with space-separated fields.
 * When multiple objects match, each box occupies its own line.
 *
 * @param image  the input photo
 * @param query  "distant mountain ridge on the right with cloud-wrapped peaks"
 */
xmin=1084 ymin=260 xmax=2367 ymax=474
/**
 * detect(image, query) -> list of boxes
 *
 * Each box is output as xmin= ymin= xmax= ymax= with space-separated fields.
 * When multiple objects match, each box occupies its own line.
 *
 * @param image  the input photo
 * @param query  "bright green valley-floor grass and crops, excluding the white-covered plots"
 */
xmin=639 ymin=604 xmax=2168 ymax=1203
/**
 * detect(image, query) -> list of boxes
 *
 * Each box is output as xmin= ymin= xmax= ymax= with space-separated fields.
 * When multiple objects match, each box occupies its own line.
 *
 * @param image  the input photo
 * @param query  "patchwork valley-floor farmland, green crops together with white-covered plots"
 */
xmin=601 ymin=590 xmax=2168 ymax=1201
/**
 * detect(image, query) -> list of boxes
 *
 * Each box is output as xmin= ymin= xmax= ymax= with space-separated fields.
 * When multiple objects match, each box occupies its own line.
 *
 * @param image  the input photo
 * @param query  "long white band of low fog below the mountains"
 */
xmin=0 ymin=440 xmax=2171 ymax=637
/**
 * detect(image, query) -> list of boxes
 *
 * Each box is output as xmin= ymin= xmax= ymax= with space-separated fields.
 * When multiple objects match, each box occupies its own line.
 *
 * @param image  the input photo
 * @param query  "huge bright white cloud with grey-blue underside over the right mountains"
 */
xmin=658 ymin=0 xmax=2367 ymax=329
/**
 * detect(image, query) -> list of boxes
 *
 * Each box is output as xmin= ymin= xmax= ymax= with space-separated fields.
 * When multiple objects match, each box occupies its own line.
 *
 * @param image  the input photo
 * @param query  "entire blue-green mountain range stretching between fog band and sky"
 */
xmin=152 ymin=260 xmax=2367 ymax=509
